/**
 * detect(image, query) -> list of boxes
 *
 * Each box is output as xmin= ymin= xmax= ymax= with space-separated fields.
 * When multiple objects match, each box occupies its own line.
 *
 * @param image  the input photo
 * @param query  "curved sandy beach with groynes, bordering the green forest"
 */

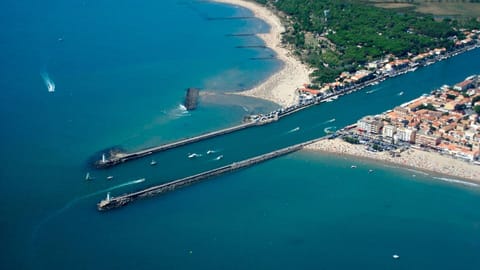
xmin=212 ymin=0 xmax=311 ymax=107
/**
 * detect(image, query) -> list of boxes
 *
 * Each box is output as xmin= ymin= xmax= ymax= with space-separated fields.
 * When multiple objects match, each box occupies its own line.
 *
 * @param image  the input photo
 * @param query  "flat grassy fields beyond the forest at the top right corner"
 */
xmin=367 ymin=0 xmax=480 ymax=18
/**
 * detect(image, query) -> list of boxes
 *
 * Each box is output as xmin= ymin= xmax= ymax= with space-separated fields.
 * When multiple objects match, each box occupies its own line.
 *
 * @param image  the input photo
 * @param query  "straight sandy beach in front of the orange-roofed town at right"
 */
xmin=306 ymin=138 xmax=480 ymax=184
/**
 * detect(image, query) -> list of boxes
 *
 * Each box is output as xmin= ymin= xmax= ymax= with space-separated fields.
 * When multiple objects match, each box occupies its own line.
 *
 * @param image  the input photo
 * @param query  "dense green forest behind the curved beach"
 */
xmin=256 ymin=0 xmax=479 ymax=83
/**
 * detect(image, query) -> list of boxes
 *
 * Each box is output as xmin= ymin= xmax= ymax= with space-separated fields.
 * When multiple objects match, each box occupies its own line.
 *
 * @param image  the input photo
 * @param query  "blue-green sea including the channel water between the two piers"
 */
xmin=0 ymin=0 xmax=480 ymax=270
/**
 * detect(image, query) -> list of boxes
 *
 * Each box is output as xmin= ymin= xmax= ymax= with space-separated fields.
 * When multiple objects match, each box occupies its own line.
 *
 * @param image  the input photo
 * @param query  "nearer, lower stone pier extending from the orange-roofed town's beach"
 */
xmin=97 ymin=137 xmax=326 ymax=211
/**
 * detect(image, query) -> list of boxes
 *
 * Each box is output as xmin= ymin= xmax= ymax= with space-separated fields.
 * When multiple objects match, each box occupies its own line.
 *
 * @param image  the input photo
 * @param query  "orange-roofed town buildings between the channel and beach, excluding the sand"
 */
xmin=339 ymin=75 xmax=480 ymax=164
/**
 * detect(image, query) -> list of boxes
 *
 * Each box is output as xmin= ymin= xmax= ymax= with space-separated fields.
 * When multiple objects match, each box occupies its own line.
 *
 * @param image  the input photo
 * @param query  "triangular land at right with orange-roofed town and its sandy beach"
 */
xmin=307 ymin=75 xmax=480 ymax=181
